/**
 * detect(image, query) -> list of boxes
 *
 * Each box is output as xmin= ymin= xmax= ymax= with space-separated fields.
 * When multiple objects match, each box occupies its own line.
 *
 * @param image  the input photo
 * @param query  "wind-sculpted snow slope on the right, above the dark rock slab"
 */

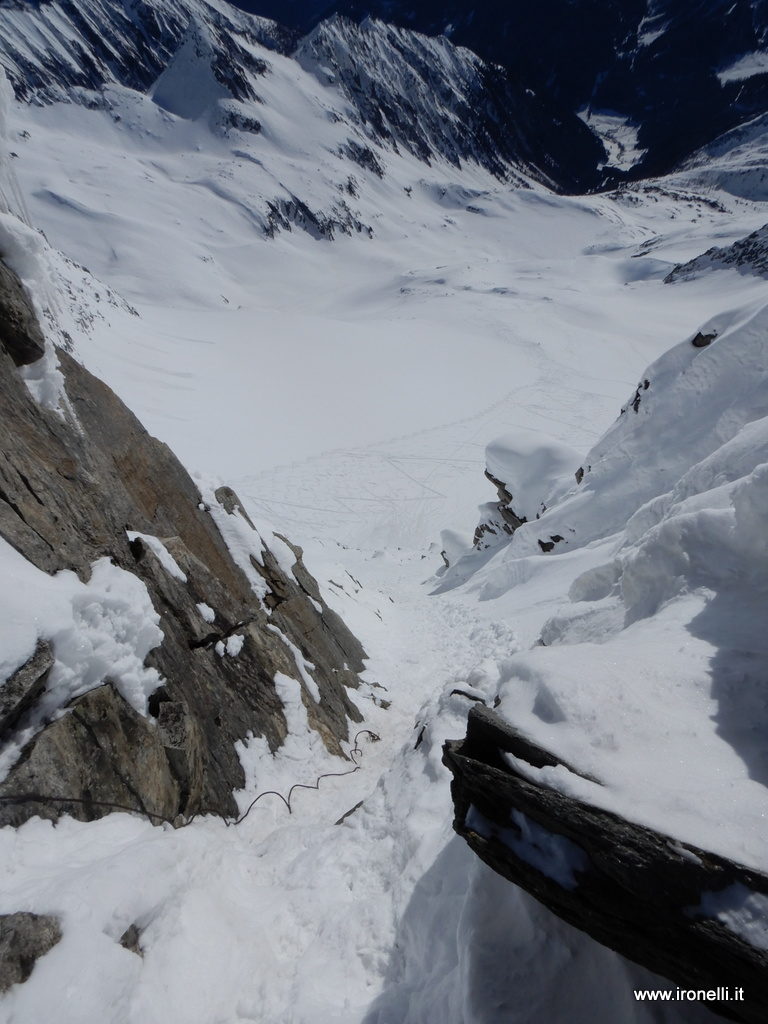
xmin=443 ymin=306 xmax=768 ymax=871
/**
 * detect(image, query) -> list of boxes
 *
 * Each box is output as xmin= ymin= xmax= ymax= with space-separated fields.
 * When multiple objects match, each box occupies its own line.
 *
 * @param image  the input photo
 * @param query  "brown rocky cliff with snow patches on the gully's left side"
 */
xmin=0 ymin=253 xmax=365 ymax=824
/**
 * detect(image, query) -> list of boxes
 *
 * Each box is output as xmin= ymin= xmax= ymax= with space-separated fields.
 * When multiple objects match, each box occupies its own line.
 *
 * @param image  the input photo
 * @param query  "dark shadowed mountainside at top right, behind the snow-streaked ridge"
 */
xmin=246 ymin=0 xmax=768 ymax=181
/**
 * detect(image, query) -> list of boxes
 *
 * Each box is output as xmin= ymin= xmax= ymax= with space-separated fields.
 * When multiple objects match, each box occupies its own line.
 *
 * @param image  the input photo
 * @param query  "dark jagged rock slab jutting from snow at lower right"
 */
xmin=443 ymin=708 xmax=768 ymax=1024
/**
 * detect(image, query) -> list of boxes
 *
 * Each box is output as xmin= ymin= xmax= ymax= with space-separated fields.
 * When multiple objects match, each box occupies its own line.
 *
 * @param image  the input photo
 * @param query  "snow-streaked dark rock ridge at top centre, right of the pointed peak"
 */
xmin=295 ymin=17 xmax=602 ymax=189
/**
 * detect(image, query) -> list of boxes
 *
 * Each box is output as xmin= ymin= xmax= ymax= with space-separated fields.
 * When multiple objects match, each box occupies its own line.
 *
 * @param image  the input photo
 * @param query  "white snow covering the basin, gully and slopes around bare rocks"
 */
xmin=0 ymin=4 xmax=768 ymax=1024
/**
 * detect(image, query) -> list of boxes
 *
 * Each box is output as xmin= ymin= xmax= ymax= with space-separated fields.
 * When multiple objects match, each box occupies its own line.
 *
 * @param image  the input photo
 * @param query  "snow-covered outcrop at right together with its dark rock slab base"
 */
xmin=442 ymin=305 xmax=768 ymax=1022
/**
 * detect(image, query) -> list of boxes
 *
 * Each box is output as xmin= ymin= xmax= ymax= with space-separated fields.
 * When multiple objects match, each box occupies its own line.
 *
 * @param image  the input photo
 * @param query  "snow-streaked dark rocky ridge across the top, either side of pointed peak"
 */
xmin=0 ymin=0 xmax=604 ymax=190
